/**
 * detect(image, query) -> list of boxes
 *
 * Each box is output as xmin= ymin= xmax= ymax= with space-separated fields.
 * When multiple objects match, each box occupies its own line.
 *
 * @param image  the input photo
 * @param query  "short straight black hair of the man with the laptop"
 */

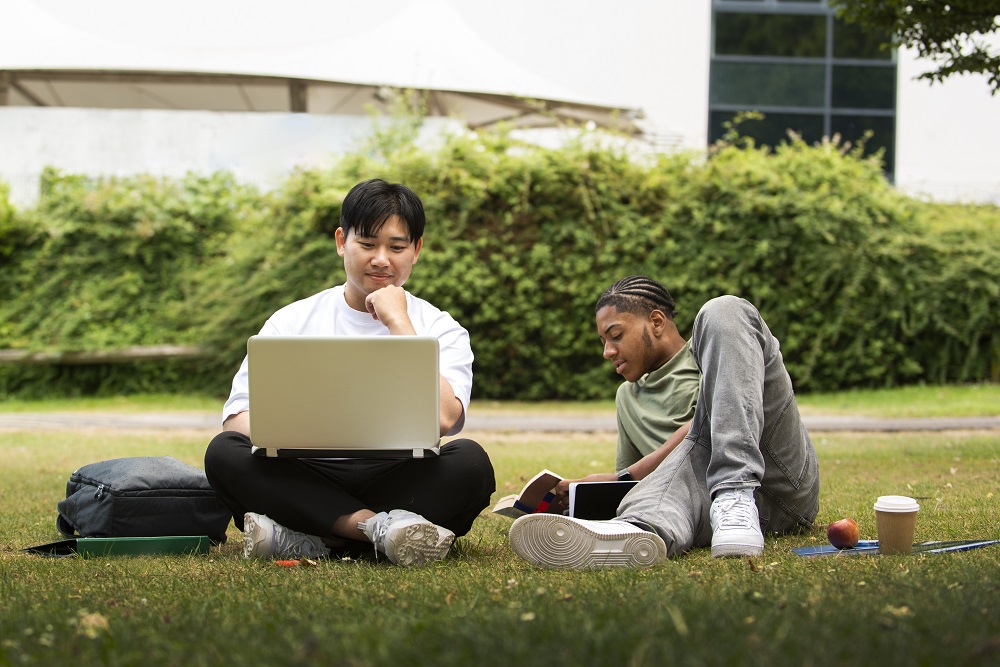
xmin=340 ymin=178 xmax=425 ymax=244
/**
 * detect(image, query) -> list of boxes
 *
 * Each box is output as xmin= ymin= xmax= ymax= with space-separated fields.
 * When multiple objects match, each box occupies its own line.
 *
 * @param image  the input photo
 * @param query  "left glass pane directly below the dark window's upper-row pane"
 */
xmin=709 ymin=62 xmax=826 ymax=107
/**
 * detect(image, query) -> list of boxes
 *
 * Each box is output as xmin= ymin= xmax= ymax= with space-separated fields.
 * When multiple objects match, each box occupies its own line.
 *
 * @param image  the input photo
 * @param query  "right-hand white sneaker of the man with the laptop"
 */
xmin=358 ymin=510 xmax=455 ymax=565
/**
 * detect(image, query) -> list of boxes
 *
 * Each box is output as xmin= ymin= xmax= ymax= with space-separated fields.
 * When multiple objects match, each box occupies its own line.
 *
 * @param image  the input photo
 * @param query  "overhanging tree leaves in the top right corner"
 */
xmin=830 ymin=0 xmax=1000 ymax=95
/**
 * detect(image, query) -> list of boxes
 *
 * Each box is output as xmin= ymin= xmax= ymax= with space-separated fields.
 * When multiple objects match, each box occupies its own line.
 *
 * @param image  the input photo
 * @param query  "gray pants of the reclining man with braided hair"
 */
xmin=618 ymin=296 xmax=819 ymax=556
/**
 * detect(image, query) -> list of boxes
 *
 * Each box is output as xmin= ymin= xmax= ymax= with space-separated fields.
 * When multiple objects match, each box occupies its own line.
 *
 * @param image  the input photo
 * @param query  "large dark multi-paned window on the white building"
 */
xmin=709 ymin=0 xmax=896 ymax=178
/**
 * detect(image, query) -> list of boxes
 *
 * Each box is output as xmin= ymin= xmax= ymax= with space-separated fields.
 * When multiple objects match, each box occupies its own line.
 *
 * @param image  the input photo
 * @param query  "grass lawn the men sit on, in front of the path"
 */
xmin=0 ymin=420 xmax=1000 ymax=667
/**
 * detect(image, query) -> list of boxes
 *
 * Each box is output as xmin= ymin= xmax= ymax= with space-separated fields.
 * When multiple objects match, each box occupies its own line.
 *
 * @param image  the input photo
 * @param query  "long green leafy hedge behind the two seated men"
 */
xmin=0 ymin=128 xmax=1000 ymax=399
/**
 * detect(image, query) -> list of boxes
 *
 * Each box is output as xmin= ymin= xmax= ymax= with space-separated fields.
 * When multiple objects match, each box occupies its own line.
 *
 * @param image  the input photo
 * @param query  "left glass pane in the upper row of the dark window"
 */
xmin=715 ymin=12 xmax=826 ymax=58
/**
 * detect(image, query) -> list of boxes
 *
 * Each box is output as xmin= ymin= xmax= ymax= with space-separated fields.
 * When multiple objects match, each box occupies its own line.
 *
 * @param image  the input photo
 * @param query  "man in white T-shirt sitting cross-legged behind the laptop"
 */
xmin=205 ymin=179 xmax=496 ymax=565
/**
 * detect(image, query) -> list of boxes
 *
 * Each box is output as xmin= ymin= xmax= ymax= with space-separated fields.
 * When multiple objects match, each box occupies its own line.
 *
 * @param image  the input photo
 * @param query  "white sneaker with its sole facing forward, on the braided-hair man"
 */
xmin=510 ymin=514 xmax=667 ymax=570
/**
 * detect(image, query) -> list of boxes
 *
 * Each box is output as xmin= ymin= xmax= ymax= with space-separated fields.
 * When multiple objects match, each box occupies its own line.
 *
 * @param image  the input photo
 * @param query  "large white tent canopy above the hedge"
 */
xmin=0 ymin=0 xmax=641 ymax=134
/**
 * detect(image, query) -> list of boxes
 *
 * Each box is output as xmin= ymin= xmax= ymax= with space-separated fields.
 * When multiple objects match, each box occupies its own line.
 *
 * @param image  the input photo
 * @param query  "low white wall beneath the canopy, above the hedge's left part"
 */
xmin=0 ymin=107 xmax=456 ymax=206
